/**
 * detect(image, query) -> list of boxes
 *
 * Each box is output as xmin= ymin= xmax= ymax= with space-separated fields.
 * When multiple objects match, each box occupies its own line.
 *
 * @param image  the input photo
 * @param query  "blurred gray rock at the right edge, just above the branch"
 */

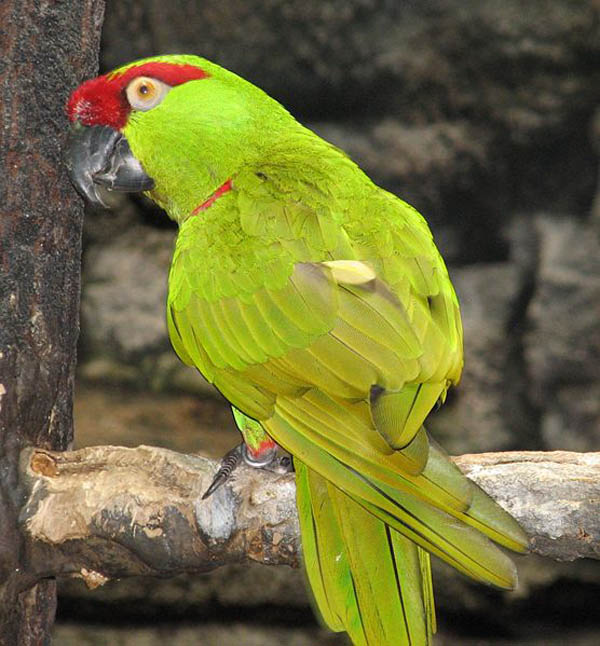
xmin=525 ymin=216 xmax=600 ymax=450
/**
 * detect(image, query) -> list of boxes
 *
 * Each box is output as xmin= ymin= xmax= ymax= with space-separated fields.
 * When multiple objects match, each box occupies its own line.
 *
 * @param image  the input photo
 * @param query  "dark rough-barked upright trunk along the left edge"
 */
xmin=0 ymin=0 xmax=104 ymax=646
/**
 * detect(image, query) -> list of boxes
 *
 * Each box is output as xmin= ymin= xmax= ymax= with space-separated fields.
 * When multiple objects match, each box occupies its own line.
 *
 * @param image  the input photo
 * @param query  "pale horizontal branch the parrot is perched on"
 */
xmin=16 ymin=446 xmax=600 ymax=587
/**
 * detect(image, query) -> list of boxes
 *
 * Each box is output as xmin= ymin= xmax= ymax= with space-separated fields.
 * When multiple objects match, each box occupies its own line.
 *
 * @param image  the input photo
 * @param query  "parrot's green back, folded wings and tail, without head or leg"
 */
xmin=168 ymin=169 xmax=526 ymax=645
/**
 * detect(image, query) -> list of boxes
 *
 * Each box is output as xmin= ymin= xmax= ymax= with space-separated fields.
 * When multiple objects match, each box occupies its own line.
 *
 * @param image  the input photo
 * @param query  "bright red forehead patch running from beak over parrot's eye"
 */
xmin=66 ymin=62 xmax=210 ymax=130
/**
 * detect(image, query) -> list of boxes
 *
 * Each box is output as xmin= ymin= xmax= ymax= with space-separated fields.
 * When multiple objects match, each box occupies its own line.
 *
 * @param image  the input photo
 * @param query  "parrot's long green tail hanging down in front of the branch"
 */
xmin=295 ymin=460 xmax=434 ymax=646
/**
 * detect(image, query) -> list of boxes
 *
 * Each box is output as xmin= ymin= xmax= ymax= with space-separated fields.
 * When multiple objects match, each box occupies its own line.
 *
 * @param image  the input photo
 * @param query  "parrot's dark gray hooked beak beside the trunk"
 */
xmin=65 ymin=124 xmax=154 ymax=207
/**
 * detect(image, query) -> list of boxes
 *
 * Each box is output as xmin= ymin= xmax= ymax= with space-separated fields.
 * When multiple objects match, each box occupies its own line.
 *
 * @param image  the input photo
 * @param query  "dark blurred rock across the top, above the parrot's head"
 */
xmin=103 ymin=0 xmax=600 ymax=139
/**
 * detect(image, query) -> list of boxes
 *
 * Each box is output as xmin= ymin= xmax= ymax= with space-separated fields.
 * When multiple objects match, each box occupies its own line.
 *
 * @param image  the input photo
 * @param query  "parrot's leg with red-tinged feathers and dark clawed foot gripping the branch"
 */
xmin=202 ymin=408 xmax=294 ymax=500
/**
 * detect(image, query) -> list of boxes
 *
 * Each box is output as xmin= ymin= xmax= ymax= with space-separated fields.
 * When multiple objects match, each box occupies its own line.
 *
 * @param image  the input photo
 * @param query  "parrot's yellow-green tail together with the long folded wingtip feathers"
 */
xmin=265 ymin=403 xmax=527 ymax=646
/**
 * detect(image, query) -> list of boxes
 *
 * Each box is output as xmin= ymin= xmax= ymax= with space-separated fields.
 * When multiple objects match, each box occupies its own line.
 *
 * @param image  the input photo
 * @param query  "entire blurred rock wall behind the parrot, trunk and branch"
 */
xmin=54 ymin=0 xmax=600 ymax=646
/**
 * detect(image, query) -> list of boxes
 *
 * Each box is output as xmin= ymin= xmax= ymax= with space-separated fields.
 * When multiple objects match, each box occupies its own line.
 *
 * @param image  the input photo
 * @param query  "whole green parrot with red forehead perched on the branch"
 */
xmin=67 ymin=56 xmax=527 ymax=646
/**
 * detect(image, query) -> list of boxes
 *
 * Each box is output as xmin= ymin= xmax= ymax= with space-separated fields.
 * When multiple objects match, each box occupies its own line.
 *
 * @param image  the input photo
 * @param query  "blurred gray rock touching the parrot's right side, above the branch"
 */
xmin=427 ymin=263 xmax=525 ymax=454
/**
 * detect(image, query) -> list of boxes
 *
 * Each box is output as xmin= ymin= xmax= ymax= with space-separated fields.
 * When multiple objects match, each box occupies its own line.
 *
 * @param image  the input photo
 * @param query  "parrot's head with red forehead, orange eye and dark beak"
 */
xmin=66 ymin=56 xmax=295 ymax=221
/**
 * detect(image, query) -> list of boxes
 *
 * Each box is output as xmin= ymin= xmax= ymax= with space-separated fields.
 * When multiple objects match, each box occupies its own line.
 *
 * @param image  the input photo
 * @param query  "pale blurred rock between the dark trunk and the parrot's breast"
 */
xmin=80 ymin=222 xmax=213 ymax=392
